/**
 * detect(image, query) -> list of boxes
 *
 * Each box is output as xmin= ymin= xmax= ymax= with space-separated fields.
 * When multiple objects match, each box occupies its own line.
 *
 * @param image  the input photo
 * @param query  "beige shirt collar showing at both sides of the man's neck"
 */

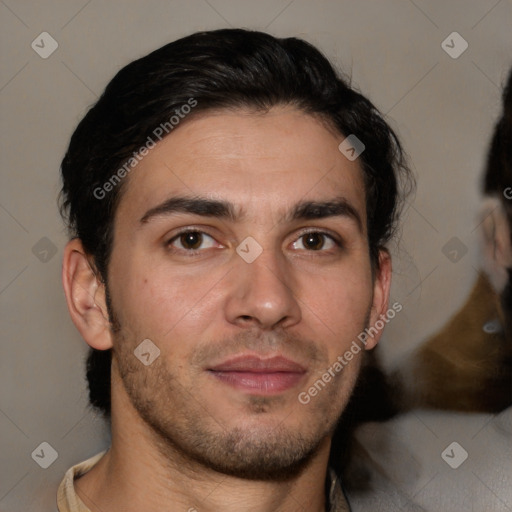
xmin=57 ymin=451 xmax=350 ymax=512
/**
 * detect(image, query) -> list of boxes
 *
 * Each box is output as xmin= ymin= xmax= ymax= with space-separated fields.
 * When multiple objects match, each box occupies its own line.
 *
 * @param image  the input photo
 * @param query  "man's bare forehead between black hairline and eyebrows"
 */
xmin=117 ymin=107 xmax=366 ymax=225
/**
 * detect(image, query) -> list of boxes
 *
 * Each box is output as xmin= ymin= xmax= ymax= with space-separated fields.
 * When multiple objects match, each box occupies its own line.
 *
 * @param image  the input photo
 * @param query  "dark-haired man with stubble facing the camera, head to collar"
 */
xmin=58 ymin=30 xmax=408 ymax=512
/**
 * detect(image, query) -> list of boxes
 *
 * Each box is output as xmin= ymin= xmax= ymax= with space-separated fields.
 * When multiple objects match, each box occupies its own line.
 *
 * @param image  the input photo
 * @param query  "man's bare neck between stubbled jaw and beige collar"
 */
xmin=75 ymin=374 xmax=331 ymax=512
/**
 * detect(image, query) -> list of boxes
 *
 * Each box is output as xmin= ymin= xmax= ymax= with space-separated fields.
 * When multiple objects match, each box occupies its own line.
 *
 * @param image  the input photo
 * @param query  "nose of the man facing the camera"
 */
xmin=226 ymin=245 xmax=301 ymax=330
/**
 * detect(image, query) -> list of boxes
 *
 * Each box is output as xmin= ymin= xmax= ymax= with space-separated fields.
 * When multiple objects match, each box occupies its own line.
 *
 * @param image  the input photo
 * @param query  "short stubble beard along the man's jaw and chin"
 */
xmin=109 ymin=290 xmax=358 ymax=481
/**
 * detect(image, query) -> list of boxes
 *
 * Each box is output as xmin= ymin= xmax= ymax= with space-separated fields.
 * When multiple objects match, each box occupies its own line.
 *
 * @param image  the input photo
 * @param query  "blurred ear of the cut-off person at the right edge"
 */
xmin=480 ymin=198 xmax=512 ymax=292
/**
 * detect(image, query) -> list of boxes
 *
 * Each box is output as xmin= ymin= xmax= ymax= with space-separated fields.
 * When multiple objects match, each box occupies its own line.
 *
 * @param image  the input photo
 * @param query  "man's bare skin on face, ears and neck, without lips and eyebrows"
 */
xmin=63 ymin=107 xmax=391 ymax=512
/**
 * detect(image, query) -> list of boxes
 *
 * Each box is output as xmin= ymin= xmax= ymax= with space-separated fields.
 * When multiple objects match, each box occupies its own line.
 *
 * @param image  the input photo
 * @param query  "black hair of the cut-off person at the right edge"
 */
xmin=483 ymin=69 xmax=512 ymax=222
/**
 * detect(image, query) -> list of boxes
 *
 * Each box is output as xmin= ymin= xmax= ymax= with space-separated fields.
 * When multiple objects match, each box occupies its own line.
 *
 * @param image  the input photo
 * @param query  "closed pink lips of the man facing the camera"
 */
xmin=208 ymin=355 xmax=306 ymax=395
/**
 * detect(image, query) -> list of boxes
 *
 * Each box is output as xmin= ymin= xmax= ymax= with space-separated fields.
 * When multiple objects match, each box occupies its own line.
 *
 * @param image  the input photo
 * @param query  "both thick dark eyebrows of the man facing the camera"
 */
xmin=139 ymin=196 xmax=363 ymax=232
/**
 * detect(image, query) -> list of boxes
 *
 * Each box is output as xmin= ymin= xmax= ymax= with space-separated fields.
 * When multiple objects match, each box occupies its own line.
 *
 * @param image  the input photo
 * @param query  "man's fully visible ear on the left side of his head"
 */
xmin=62 ymin=238 xmax=112 ymax=350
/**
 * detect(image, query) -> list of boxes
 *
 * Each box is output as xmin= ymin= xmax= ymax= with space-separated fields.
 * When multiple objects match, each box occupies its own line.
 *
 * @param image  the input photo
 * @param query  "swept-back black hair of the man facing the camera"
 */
xmin=60 ymin=29 xmax=412 ymax=418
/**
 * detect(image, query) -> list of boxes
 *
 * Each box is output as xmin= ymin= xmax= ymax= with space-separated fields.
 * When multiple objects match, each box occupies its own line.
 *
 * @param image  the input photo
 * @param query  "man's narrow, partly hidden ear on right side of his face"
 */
xmin=365 ymin=249 xmax=392 ymax=350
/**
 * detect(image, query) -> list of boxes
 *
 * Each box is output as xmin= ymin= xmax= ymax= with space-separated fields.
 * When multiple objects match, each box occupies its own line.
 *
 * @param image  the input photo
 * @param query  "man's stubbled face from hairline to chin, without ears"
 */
xmin=105 ymin=108 xmax=384 ymax=478
